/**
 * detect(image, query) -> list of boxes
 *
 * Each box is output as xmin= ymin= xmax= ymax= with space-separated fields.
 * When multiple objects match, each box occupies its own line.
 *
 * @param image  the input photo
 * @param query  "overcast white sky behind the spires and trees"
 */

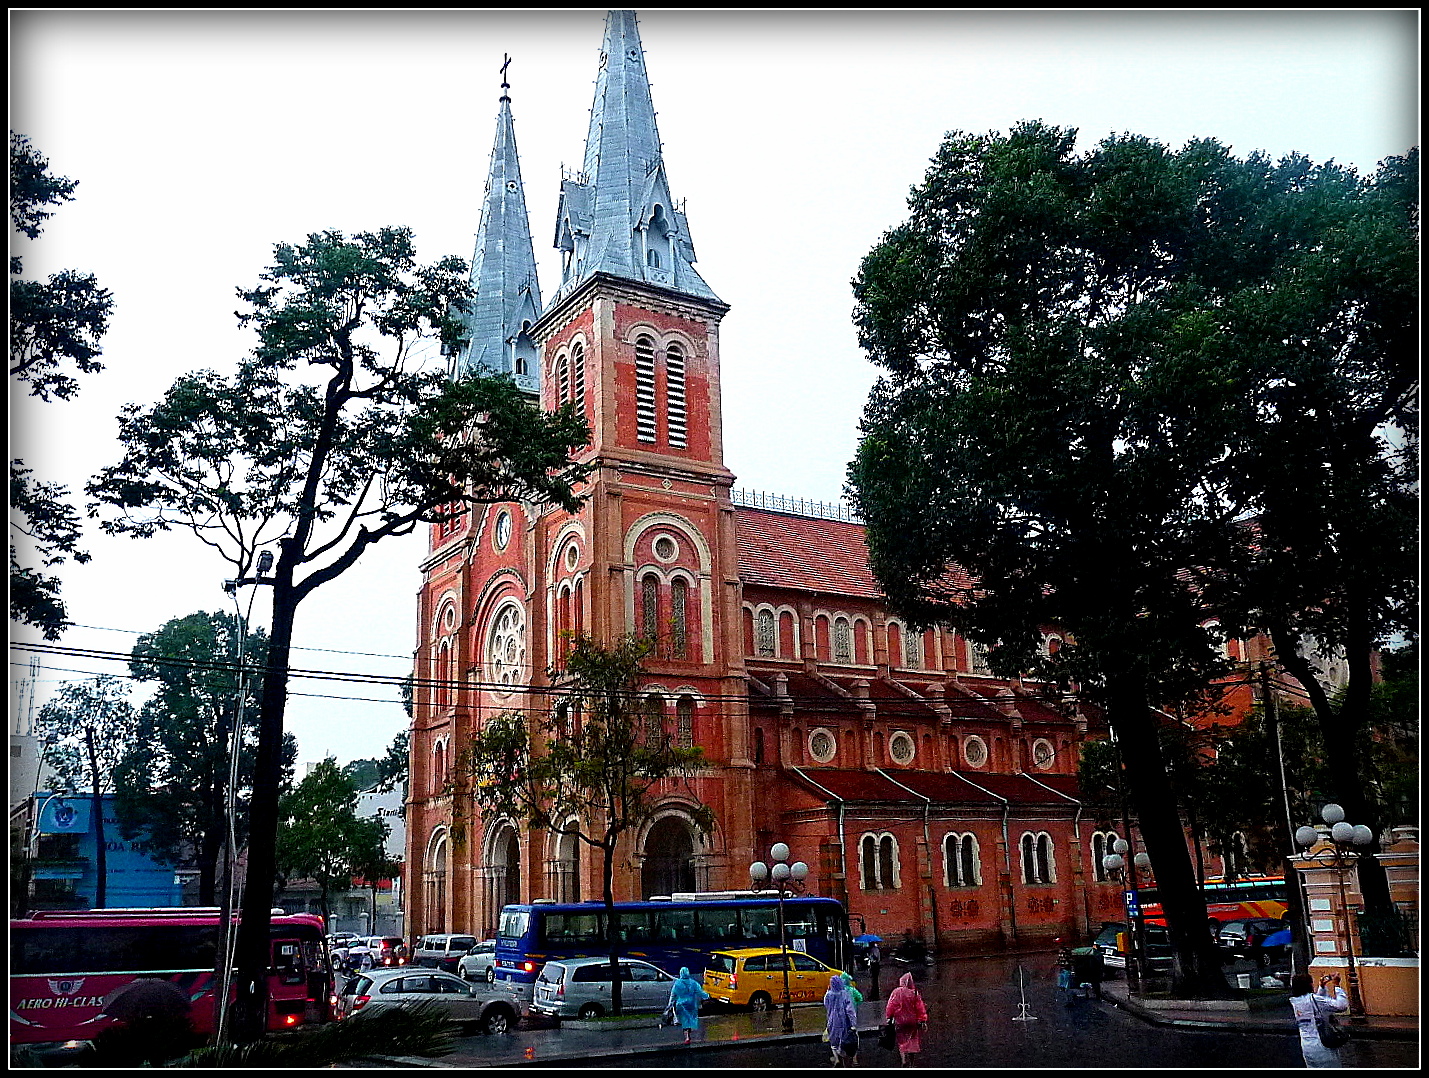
xmin=10 ymin=9 xmax=1419 ymax=762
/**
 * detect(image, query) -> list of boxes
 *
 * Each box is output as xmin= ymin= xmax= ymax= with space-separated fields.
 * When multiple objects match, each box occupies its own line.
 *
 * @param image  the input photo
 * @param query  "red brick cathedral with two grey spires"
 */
xmin=406 ymin=11 xmax=1137 ymax=949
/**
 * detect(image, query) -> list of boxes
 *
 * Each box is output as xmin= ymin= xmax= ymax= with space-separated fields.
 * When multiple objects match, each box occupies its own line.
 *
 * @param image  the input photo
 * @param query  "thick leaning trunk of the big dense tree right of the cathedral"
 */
xmin=1106 ymin=673 xmax=1229 ymax=995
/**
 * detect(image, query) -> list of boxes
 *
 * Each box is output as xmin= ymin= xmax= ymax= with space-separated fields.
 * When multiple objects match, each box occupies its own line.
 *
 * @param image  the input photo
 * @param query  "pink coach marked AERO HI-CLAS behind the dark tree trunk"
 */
xmin=10 ymin=908 xmax=332 ymax=1059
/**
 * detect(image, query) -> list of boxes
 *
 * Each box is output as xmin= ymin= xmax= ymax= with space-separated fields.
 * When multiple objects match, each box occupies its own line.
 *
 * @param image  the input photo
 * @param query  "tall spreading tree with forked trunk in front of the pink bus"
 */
xmin=87 ymin=229 xmax=589 ymax=1039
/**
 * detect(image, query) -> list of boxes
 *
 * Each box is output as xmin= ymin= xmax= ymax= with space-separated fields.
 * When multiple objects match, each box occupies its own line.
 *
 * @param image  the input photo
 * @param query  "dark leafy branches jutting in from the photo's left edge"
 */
xmin=10 ymin=132 xmax=114 ymax=641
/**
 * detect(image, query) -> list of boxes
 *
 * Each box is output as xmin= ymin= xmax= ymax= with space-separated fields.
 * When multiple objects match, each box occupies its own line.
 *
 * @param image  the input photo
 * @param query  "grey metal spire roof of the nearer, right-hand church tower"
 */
xmin=556 ymin=11 xmax=719 ymax=302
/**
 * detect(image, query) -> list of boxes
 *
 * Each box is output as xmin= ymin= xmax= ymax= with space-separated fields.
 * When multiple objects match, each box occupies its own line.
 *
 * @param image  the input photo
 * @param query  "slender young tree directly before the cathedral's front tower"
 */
xmin=452 ymin=636 xmax=715 ymax=1014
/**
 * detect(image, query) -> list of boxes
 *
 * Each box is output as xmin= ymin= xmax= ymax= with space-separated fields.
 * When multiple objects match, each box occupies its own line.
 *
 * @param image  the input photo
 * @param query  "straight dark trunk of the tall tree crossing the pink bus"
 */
xmin=233 ymin=563 xmax=297 ymax=1044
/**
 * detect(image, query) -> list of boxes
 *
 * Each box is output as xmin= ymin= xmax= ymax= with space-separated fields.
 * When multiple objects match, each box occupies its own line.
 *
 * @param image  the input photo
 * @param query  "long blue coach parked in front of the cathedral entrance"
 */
xmin=496 ymin=892 xmax=853 ymax=1005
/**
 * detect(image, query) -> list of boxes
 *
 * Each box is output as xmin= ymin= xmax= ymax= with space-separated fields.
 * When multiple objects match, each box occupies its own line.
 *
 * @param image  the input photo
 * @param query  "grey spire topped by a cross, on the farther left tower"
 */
xmin=453 ymin=56 xmax=542 ymax=392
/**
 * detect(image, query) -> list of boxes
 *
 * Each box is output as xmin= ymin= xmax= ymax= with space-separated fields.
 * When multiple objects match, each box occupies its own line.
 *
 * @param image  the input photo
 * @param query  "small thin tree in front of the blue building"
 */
xmin=36 ymin=673 xmax=137 ymax=908
